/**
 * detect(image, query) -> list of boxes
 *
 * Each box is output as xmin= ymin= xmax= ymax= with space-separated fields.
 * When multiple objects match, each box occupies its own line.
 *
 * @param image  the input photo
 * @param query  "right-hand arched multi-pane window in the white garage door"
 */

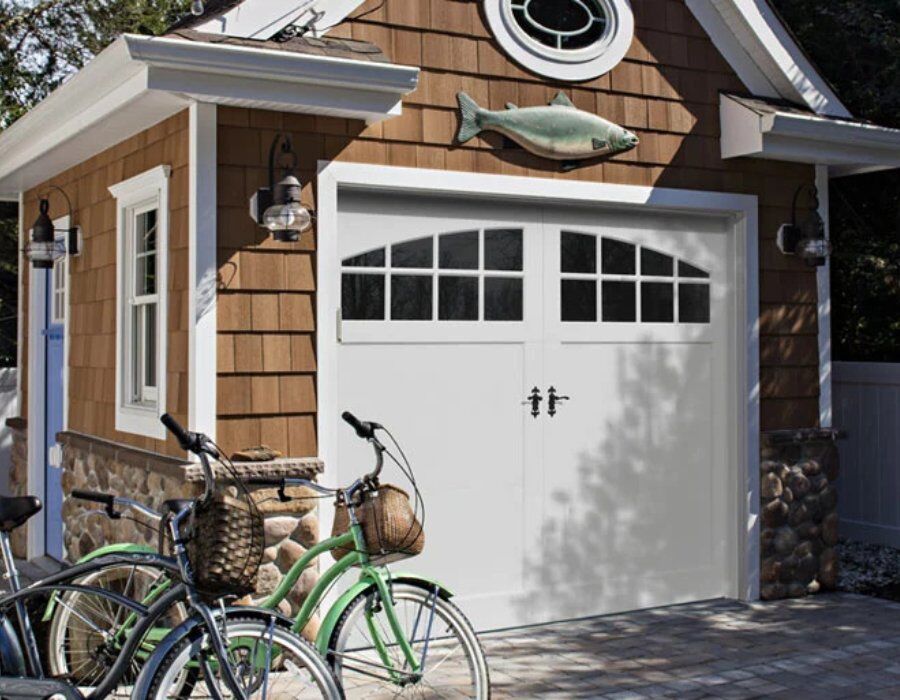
xmin=560 ymin=231 xmax=710 ymax=324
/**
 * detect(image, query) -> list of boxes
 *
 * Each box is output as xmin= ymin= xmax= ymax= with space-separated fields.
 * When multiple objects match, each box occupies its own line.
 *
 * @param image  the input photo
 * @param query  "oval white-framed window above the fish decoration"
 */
xmin=483 ymin=0 xmax=634 ymax=82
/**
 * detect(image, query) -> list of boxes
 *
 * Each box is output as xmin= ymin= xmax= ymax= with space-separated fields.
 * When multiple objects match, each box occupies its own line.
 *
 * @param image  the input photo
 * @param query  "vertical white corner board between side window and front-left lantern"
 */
xmin=188 ymin=102 xmax=217 ymax=440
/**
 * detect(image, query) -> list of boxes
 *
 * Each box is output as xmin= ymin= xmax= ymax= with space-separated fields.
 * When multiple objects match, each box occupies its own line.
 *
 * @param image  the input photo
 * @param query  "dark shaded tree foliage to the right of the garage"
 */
xmin=773 ymin=0 xmax=900 ymax=362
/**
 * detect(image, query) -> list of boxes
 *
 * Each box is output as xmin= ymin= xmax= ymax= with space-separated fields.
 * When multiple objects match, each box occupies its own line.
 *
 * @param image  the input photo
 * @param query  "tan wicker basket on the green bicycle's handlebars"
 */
xmin=331 ymin=484 xmax=425 ymax=564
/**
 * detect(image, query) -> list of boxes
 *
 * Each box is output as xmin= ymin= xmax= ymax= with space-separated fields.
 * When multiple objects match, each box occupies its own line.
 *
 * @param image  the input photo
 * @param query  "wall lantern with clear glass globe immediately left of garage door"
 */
xmin=250 ymin=134 xmax=313 ymax=242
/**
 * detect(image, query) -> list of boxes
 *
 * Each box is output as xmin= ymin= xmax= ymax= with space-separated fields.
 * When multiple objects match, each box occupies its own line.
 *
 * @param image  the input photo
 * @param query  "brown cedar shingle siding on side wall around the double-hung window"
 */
xmin=20 ymin=111 xmax=188 ymax=457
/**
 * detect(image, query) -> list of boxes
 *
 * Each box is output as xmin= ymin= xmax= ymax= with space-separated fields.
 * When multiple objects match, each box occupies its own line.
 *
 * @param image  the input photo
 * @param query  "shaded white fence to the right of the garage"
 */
xmin=833 ymin=362 xmax=900 ymax=547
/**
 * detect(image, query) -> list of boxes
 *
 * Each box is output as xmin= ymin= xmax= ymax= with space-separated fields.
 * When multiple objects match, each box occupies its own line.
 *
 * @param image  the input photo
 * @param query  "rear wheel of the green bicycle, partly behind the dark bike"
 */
xmin=47 ymin=564 xmax=188 ymax=697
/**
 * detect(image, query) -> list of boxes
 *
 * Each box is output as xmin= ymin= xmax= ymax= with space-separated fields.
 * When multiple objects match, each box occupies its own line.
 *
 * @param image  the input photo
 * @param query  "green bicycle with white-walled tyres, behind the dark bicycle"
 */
xmin=44 ymin=412 xmax=490 ymax=700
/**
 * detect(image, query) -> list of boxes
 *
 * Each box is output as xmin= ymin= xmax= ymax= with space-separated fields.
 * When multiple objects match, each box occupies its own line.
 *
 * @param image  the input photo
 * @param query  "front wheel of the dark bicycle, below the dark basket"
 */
xmin=147 ymin=615 xmax=343 ymax=700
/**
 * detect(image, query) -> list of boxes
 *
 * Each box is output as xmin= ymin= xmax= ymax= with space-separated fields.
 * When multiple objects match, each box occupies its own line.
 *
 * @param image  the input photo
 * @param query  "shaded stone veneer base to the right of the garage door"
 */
xmin=760 ymin=429 xmax=839 ymax=600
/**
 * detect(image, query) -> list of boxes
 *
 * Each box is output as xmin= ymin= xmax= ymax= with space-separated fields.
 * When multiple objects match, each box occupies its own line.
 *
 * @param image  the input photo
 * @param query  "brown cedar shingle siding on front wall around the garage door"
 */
xmin=218 ymin=0 xmax=819 ymax=456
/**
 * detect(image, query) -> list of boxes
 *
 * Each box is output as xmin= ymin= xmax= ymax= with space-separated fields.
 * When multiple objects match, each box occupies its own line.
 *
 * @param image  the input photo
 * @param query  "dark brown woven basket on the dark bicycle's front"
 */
xmin=187 ymin=493 xmax=264 ymax=598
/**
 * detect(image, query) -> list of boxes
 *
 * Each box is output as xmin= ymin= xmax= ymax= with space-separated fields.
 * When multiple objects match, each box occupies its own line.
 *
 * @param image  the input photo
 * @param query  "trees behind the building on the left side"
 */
xmin=0 ymin=0 xmax=190 ymax=367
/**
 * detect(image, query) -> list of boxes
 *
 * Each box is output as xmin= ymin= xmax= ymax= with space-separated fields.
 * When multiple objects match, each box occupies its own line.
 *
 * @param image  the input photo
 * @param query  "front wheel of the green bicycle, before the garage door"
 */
xmin=328 ymin=584 xmax=491 ymax=700
